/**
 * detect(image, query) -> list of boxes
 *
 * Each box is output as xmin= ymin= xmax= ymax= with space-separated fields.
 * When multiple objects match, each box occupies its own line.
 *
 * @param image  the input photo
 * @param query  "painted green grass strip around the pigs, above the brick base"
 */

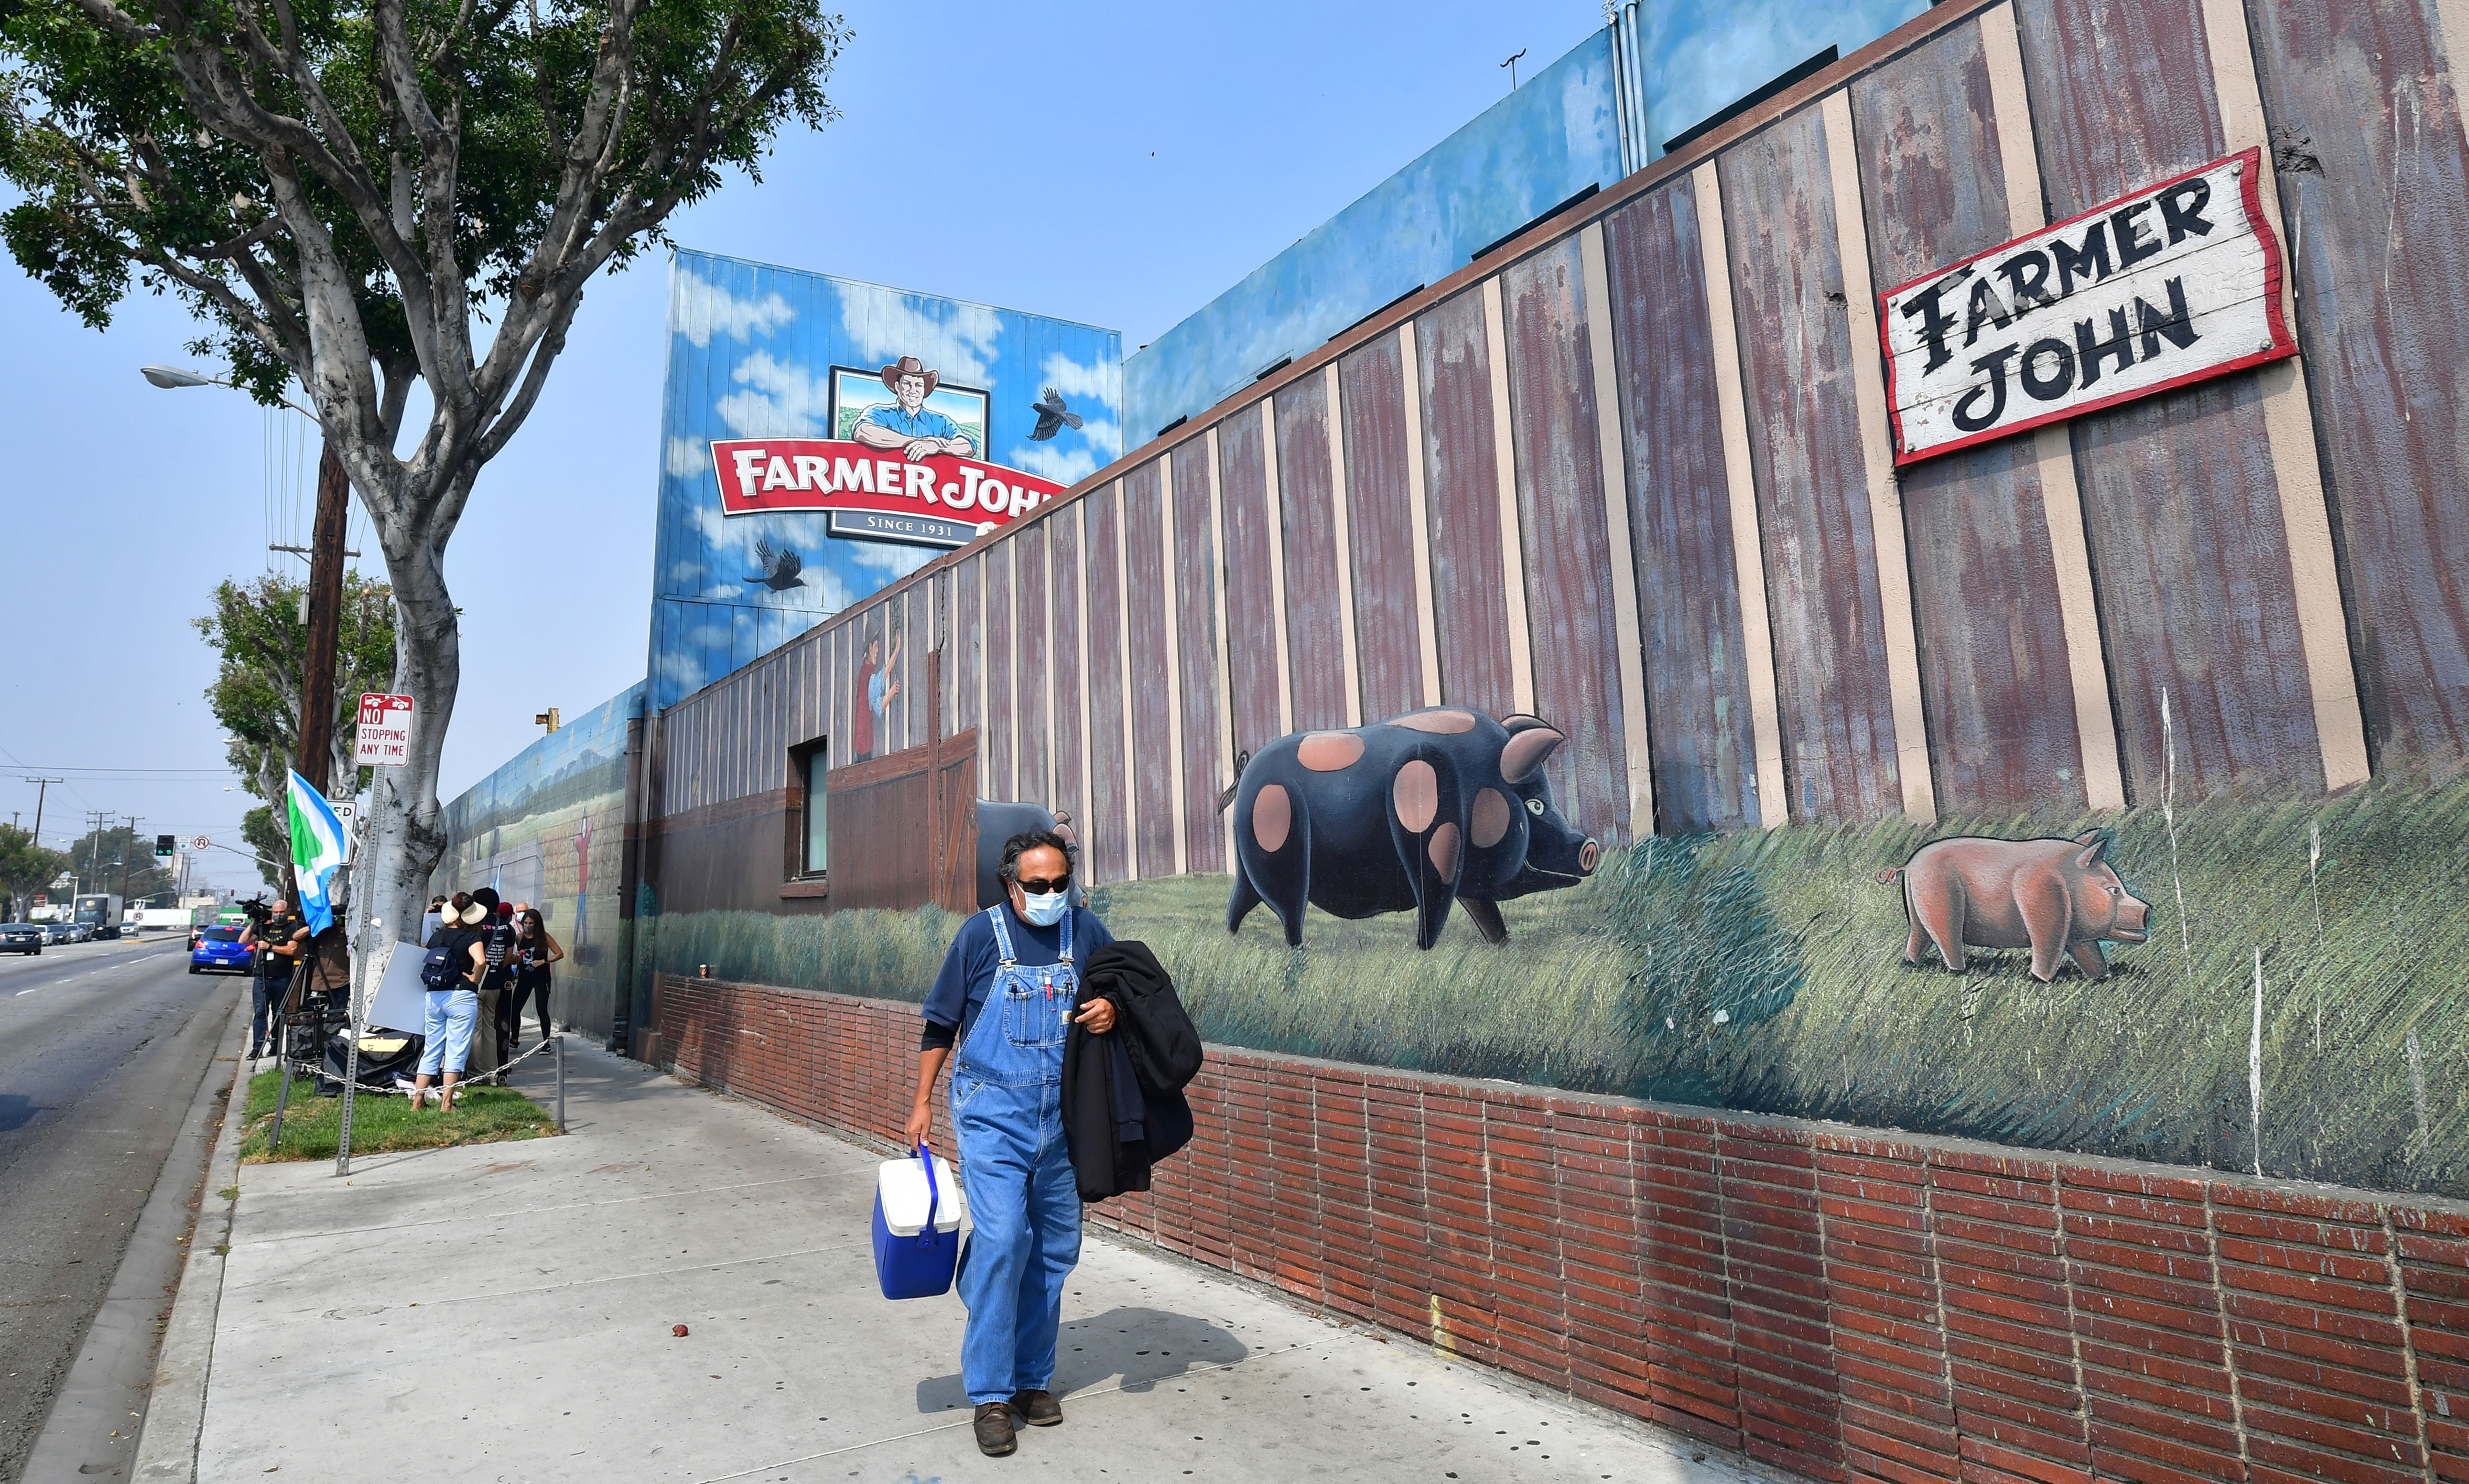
xmin=657 ymin=781 xmax=2469 ymax=1195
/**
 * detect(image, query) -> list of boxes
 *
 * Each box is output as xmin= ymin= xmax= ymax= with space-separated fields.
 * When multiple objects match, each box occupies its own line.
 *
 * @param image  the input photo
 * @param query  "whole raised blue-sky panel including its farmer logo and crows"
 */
xmin=649 ymin=250 xmax=1123 ymax=709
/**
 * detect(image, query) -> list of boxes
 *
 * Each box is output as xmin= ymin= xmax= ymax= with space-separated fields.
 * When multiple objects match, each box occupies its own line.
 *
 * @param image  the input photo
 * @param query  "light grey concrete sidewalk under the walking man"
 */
xmin=179 ymin=1037 xmax=1766 ymax=1484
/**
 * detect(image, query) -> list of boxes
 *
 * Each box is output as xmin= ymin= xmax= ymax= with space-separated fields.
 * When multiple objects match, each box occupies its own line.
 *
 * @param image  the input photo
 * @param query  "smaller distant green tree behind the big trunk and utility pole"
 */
xmin=190 ymin=573 xmax=395 ymax=859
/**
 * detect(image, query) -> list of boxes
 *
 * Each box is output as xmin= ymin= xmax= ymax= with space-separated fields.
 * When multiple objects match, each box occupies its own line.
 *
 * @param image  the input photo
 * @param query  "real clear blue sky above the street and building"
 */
xmin=0 ymin=0 xmax=1602 ymax=884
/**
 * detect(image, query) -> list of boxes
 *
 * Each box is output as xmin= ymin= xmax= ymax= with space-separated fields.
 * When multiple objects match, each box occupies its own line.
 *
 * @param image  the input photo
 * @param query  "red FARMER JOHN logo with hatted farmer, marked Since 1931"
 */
xmin=711 ymin=355 xmax=1064 ymax=546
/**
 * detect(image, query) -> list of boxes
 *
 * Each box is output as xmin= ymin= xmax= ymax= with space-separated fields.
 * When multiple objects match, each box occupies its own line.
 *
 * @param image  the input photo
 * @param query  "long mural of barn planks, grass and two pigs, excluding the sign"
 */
xmin=444 ymin=0 xmax=2469 ymax=1215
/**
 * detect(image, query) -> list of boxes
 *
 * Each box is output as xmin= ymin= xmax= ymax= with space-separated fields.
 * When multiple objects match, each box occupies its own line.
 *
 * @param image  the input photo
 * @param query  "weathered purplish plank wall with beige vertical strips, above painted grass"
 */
xmin=647 ymin=0 xmax=2469 ymax=911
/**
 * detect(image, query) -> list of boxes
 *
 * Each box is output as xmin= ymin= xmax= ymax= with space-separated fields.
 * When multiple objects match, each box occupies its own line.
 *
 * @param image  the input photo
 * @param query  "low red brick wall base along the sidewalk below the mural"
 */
xmin=644 ymin=978 xmax=2469 ymax=1484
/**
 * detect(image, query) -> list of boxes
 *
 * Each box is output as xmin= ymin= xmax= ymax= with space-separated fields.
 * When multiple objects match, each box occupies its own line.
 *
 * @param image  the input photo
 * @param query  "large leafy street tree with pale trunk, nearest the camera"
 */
xmin=0 ymin=0 xmax=844 ymax=938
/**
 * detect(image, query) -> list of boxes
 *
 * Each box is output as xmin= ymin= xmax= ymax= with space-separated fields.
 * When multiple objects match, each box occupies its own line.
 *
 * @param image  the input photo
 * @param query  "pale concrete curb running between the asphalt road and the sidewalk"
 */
xmin=128 ymin=982 xmax=250 ymax=1484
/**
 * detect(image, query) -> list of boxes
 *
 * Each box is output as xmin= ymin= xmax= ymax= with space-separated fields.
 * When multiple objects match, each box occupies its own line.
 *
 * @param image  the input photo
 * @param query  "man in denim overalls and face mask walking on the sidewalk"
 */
xmin=908 ymin=830 xmax=1113 ymax=1457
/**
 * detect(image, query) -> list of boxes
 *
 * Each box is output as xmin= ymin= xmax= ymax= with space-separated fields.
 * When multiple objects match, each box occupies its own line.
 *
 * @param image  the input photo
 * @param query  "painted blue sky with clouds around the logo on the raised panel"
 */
xmin=649 ymin=250 xmax=1123 ymax=706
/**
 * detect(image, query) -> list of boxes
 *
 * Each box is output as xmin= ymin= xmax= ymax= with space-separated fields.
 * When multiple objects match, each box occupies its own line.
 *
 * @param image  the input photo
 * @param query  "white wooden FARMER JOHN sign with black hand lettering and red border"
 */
xmin=1879 ymin=150 xmax=2296 ymax=464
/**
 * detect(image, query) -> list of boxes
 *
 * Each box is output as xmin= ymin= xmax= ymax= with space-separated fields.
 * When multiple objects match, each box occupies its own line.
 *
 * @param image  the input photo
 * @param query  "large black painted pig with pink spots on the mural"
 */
xmin=1227 ymin=706 xmax=1600 ymax=948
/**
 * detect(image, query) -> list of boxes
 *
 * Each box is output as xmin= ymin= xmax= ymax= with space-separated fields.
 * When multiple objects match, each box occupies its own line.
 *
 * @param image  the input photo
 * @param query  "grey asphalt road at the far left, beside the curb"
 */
xmin=0 ymin=934 xmax=247 ymax=1479
